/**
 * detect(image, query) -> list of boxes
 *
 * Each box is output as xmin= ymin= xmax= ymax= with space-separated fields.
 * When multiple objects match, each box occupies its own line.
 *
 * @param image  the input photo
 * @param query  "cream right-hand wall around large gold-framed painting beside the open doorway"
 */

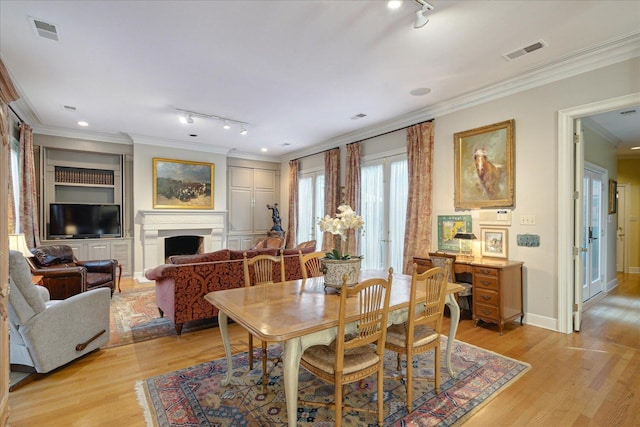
xmin=282 ymin=58 xmax=640 ymax=330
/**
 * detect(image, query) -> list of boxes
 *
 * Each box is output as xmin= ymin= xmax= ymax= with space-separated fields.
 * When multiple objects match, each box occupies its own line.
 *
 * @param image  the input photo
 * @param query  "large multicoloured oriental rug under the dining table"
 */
xmin=136 ymin=338 xmax=531 ymax=427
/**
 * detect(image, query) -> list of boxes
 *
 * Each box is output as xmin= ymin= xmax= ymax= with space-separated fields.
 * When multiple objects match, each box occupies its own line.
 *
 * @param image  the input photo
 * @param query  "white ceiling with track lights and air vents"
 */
xmin=0 ymin=0 xmax=640 ymax=158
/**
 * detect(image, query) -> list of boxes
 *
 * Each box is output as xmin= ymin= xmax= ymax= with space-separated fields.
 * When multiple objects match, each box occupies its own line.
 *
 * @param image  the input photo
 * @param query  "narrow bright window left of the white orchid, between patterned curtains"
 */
xmin=296 ymin=171 xmax=324 ymax=248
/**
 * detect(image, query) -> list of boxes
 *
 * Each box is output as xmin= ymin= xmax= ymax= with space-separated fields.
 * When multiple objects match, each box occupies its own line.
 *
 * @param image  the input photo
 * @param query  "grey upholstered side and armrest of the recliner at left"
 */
xmin=20 ymin=288 xmax=111 ymax=373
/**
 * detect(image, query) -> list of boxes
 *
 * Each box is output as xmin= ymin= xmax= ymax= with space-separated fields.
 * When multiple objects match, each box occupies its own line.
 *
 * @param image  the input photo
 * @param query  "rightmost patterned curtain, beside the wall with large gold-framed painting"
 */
xmin=403 ymin=122 xmax=434 ymax=274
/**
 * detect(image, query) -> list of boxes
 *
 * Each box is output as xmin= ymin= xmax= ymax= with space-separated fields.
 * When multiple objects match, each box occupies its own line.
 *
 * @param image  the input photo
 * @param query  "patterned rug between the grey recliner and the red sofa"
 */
xmin=103 ymin=288 xmax=217 ymax=348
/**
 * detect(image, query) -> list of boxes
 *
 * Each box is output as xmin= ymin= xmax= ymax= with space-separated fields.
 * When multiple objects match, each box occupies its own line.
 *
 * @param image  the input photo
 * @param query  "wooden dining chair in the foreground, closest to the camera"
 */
xmin=300 ymin=268 xmax=393 ymax=427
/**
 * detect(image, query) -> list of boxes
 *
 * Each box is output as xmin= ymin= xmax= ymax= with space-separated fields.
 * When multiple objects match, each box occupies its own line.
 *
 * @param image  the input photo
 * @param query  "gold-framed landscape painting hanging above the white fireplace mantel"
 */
xmin=153 ymin=158 xmax=215 ymax=209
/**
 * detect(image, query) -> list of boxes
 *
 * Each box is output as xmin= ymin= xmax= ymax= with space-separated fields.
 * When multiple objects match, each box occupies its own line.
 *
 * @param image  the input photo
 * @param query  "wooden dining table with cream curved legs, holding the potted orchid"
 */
xmin=205 ymin=270 xmax=463 ymax=427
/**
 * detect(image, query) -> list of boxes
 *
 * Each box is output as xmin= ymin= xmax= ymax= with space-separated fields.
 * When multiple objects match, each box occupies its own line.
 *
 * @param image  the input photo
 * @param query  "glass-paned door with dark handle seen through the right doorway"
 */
xmin=580 ymin=166 xmax=605 ymax=302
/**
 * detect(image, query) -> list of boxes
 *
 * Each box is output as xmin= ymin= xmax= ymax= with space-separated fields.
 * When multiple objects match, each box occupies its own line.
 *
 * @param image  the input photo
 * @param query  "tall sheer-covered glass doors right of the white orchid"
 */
xmin=361 ymin=154 xmax=409 ymax=272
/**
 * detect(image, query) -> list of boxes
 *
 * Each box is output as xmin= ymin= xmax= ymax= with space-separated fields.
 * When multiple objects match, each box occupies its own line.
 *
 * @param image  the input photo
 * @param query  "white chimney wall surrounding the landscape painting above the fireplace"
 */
xmin=133 ymin=143 xmax=227 ymax=278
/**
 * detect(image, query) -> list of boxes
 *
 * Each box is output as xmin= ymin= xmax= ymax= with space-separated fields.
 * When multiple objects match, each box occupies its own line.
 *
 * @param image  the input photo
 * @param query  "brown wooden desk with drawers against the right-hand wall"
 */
xmin=413 ymin=257 xmax=524 ymax=335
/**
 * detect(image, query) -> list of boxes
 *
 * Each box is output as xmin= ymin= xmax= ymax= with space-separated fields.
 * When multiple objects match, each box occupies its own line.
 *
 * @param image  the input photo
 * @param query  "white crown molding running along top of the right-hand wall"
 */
xmin=281 ymin=32 xmax=640 ymax=161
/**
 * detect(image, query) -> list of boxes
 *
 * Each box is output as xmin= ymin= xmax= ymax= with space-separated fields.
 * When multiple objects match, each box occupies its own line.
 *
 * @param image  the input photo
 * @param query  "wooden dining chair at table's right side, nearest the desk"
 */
xmin=385 ymin=259 xmax=452 ymax=412
